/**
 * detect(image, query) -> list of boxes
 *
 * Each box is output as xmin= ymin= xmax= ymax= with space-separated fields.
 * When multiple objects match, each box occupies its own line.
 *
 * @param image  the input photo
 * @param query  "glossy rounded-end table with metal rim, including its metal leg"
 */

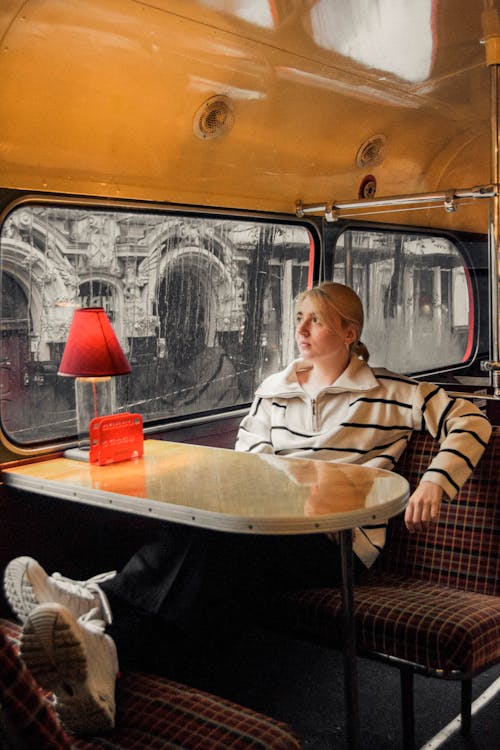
xmin=2 ymin=440 xmax=409 ymax=748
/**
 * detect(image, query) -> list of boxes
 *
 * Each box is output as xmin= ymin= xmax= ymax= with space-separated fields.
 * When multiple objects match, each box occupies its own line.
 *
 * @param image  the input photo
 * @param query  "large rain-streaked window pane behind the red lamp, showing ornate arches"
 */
xmin=0 ymin=205 xmax=311 ymax=443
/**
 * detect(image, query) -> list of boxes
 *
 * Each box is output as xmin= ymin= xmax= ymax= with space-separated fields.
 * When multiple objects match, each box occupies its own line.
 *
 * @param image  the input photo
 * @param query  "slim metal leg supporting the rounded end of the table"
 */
xmin=340 ymin=529 xmax=361 ymax=750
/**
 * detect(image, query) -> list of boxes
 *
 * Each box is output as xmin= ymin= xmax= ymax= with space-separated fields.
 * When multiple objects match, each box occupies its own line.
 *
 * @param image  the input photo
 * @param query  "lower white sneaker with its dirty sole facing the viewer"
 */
xmin=20 ymin=604 xmax=118 ymax=734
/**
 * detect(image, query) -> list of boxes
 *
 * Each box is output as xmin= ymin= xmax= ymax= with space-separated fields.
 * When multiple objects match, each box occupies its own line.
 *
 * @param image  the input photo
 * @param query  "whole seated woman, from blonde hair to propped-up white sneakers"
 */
xmin=5 ymin=282 xmax=491 ymax=731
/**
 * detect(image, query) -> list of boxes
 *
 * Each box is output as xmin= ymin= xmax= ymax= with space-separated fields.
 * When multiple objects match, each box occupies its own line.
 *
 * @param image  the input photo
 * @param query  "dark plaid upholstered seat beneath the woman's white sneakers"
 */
xmin=0 ymin=620 xmax=300 ymax=750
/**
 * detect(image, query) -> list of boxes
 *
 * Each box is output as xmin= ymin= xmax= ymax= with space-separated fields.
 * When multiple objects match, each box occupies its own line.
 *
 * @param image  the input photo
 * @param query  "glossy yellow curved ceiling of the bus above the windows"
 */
xmin=0 ymin=0 xmax=498 ymax=228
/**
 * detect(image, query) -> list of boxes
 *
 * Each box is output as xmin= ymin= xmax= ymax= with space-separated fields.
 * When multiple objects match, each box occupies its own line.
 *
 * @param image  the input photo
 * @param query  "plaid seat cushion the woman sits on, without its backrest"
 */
xmin=278 ymin=573 xmax=500 ymax=674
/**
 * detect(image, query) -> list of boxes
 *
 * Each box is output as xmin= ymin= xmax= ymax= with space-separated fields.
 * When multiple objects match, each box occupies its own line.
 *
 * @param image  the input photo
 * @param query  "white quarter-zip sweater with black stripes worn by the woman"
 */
xmin=235 ymin=356 xmax=491 ymax=567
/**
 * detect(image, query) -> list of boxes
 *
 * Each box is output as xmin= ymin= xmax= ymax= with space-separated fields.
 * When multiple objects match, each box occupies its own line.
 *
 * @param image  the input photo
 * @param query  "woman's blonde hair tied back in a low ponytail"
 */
xmin=295 ymin=281 xmax=370 ymax=362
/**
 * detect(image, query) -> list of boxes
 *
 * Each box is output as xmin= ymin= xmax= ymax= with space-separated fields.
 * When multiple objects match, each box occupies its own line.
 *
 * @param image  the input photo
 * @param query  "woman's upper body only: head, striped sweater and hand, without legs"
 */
xmin=236 ymin=282 xmax=491 ymax=567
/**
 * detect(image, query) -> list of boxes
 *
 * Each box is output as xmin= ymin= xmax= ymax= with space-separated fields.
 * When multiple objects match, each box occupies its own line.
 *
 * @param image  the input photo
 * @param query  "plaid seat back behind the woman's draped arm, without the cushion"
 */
xmin=376 ymin=427 xmax=500 ymax=596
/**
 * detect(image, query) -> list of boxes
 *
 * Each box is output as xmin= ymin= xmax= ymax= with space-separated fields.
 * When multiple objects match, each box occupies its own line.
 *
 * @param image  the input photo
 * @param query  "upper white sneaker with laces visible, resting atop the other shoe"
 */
xmin=4 ymin=557 xmax=116 ymax=624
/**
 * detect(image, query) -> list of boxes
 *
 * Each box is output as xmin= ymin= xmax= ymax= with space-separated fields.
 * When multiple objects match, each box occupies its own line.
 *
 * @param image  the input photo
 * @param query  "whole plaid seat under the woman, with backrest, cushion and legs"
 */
xmin=279 ymin=428 xmax=500 ymax=747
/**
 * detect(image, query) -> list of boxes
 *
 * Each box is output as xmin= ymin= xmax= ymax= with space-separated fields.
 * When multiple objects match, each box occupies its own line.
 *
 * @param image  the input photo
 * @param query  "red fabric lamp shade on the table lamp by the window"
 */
xmin=59 ymin=307 xmax=131 ymax=378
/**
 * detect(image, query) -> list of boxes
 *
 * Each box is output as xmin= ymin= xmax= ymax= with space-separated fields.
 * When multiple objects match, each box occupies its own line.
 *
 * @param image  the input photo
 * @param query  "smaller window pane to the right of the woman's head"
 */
xmin=334 ymin=230 xmax=471 ymax=373
